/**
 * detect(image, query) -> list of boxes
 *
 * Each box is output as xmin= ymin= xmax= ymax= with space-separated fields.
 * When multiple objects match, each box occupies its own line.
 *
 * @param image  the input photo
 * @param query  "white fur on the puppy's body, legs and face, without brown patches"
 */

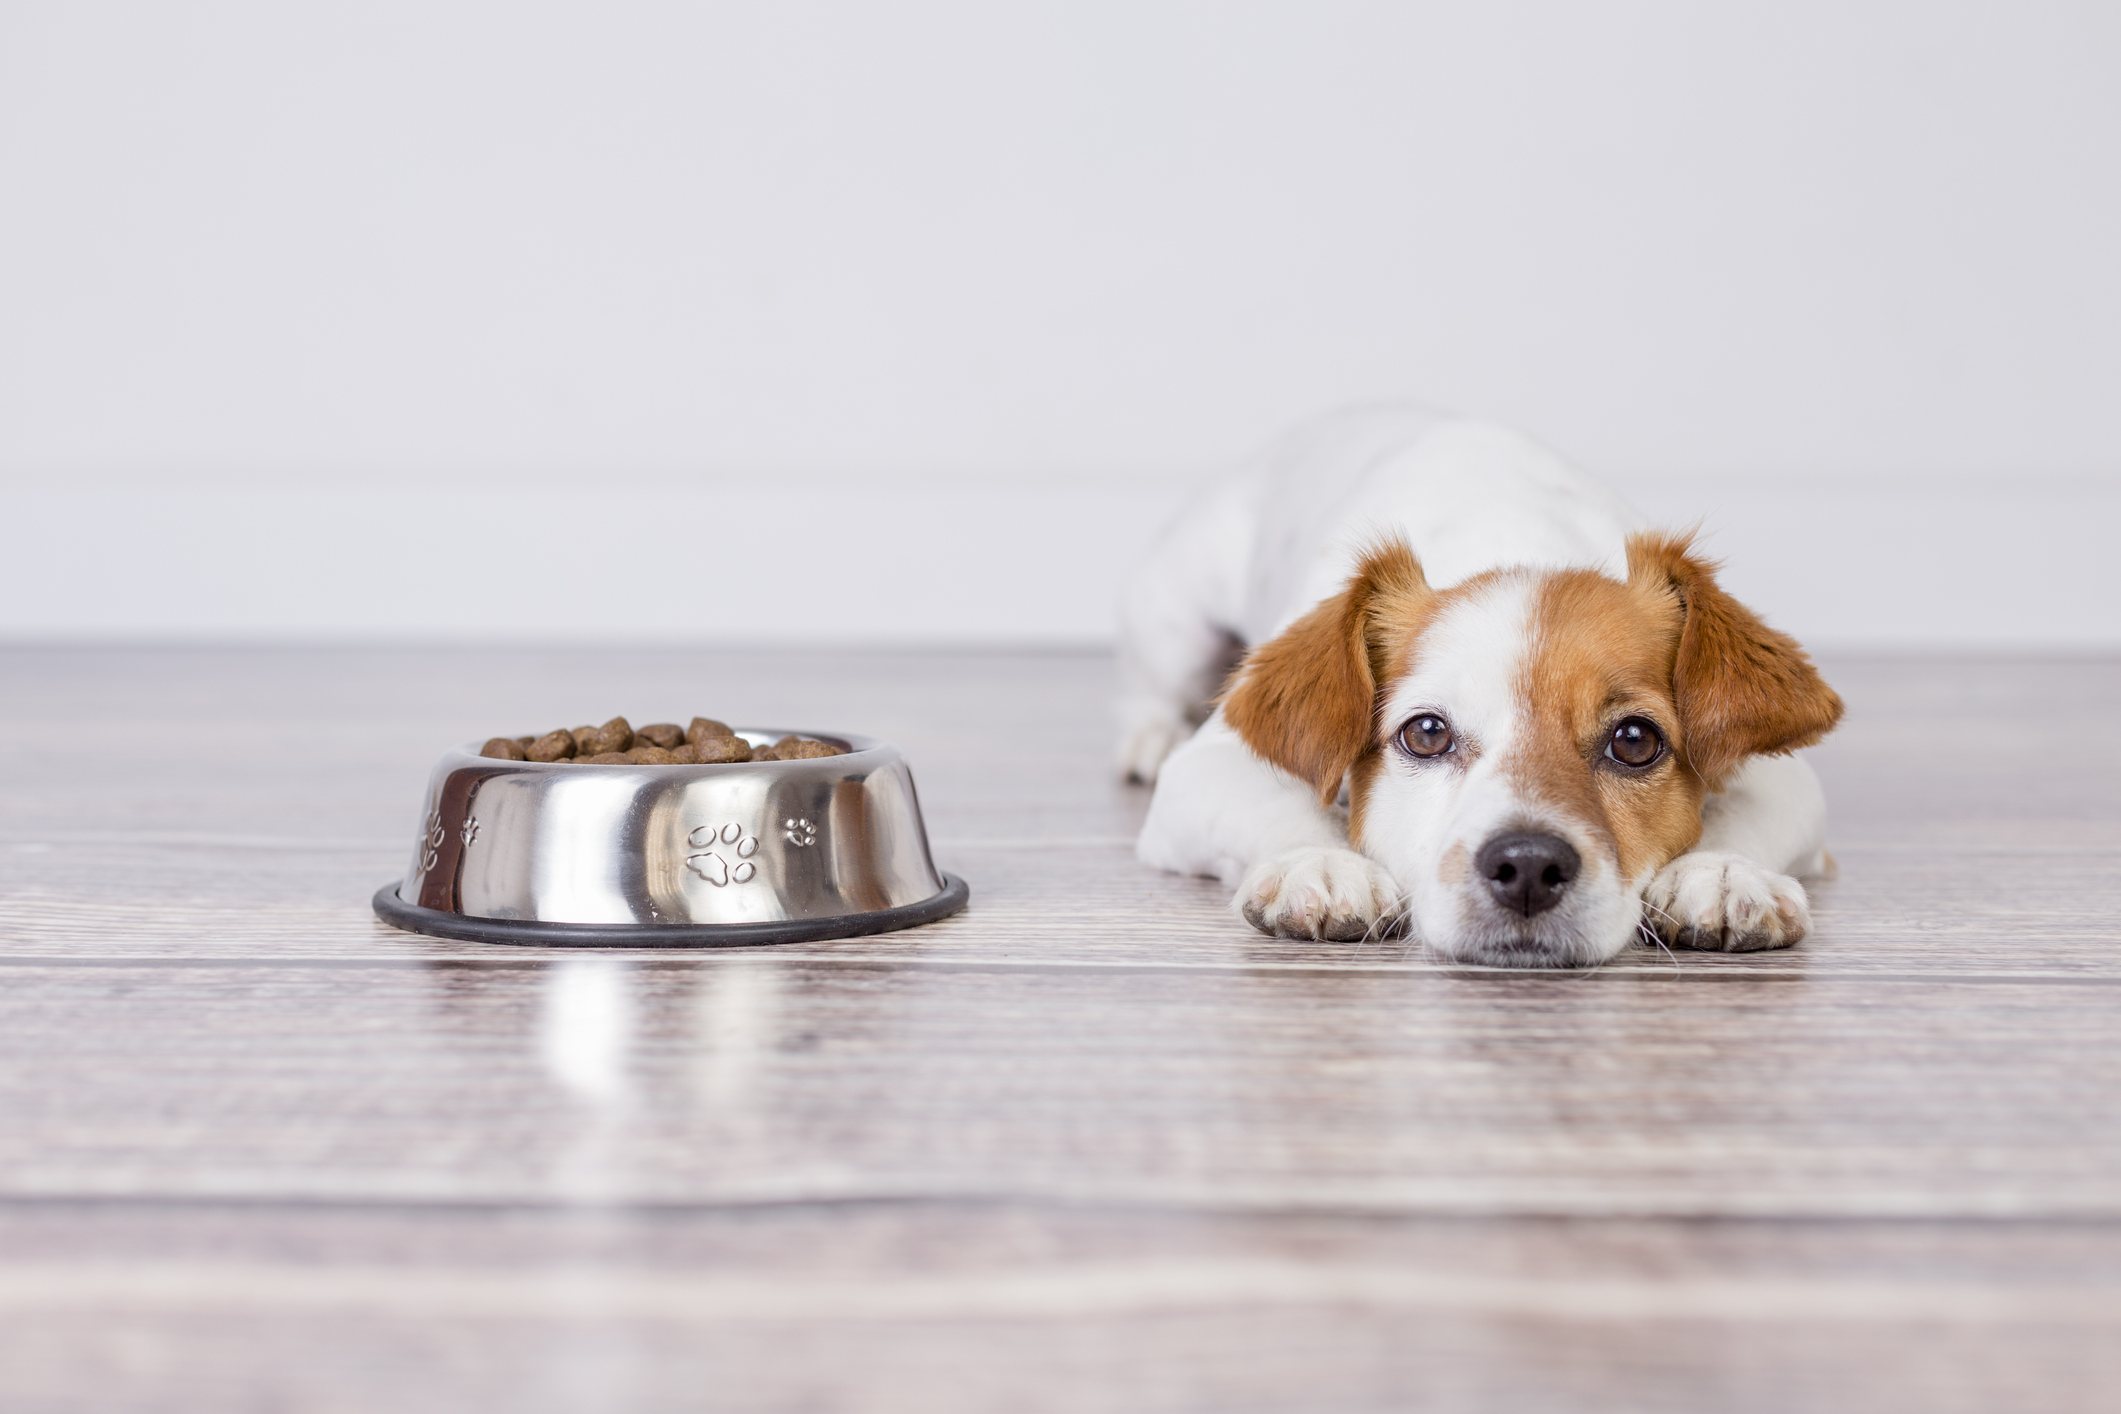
xmin=1120 ymin=409 xmax=1826 ymax=965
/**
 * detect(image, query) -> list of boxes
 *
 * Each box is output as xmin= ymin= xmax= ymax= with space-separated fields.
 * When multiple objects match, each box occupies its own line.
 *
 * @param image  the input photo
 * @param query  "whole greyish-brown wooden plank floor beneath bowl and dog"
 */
xmin=0 ymin=651 xmax=2121 ymax=1414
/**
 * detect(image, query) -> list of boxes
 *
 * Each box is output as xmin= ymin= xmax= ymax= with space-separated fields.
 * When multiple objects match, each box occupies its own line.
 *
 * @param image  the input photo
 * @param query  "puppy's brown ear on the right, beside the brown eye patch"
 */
xmin=1627 ymin=534 xmax=1841 ymax=789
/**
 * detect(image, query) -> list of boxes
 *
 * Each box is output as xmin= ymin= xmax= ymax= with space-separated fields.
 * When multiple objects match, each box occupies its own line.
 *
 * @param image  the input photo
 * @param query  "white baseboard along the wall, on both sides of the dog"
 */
xmin=0 ymin=477 xmax=2121 ymax=653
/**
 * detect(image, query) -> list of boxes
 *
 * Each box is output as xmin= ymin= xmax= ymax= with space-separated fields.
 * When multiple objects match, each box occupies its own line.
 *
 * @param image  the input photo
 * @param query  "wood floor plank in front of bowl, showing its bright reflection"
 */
xmin=0 ymin=956 xmax=2121 ymax=1217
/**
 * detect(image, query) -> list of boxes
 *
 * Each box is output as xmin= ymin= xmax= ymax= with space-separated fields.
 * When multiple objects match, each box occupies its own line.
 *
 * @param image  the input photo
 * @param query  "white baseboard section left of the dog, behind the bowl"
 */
xmin=0 ymin=483 xmax=1179 ymax=644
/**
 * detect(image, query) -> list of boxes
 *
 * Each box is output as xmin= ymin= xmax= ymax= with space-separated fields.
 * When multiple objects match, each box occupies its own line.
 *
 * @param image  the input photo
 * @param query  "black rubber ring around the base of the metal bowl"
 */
xmin=373 ymin=873 xmax=971 ymax=948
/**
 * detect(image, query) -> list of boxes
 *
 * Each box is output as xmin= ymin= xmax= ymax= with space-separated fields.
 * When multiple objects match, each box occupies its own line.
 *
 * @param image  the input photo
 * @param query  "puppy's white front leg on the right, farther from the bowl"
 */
xmin=1642 ymin=757 xmax=1830 ymax=952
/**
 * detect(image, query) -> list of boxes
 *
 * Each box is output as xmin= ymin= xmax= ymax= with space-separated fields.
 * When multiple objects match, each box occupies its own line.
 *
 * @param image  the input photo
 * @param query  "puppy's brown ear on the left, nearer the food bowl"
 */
xmin=1222 ymin=538 xmax=1432 ymax=806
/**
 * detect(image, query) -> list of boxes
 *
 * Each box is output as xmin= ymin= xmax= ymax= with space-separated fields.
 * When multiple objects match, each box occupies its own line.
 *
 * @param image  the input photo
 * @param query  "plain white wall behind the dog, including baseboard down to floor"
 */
xmin=0 ymin=0 xmax=2121 ymax=649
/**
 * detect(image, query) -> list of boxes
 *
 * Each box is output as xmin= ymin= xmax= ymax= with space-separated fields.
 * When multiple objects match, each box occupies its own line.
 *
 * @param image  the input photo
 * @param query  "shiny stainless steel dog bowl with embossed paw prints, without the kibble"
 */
xmin=375 ymin=727 xmax=967 ymax=948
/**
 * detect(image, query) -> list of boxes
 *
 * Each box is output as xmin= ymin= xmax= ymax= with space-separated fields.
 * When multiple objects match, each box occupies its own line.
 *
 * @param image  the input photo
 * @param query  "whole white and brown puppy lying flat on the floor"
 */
xmin=1120 ymin=407 xmax=1841 ymax=967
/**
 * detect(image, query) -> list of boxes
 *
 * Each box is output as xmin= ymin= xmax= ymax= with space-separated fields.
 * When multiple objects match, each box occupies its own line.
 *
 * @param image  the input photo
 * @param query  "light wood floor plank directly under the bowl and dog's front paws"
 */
xmin=0 ymin=833 xmax=2121 ymax=979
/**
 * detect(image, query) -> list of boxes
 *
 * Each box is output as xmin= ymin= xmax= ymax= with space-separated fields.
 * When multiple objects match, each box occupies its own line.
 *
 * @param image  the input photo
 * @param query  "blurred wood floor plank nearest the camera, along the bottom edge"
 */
xmin=0 ymin=1204 xmax=2121 ymax=1414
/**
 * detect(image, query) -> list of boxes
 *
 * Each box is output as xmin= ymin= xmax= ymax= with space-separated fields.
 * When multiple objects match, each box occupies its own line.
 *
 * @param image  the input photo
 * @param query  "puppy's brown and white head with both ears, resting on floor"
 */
xmin=1224 ymin=534 xmax=1841 ymax=967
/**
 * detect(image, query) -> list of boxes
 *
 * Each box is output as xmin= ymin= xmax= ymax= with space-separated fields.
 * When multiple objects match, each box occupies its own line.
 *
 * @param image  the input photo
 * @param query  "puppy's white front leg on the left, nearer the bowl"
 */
xmin=1135 ymin=712 xmax=1400 ymax=941
